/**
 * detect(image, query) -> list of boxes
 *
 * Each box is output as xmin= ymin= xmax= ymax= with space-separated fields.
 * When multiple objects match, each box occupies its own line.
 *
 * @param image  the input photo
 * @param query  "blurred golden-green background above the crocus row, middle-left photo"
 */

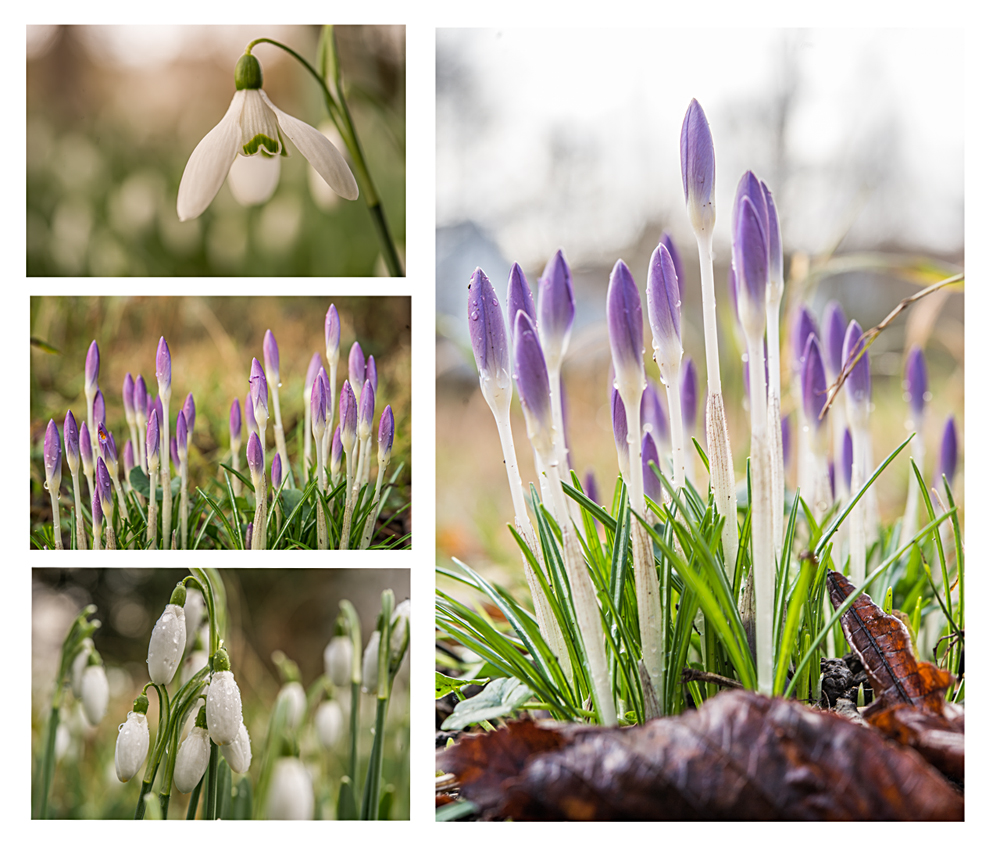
xmin=30 ymin=296 xmax=412 ymax=533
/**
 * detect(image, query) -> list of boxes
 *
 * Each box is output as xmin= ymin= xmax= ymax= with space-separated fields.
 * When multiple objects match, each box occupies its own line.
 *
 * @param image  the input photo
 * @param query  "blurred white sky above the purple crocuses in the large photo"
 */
xmin=437 ymin=28 xmax=965 ymax=266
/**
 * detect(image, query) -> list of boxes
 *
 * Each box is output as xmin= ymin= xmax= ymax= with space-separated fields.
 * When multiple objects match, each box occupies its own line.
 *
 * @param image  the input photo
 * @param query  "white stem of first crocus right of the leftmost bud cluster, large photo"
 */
xmin=618 ymin=396 xmax=663 ymax=717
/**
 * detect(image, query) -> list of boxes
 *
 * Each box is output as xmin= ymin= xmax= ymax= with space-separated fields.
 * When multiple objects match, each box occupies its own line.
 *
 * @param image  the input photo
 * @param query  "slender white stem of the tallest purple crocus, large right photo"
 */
xmin=695 ymin=229 xmax=739 ymax=579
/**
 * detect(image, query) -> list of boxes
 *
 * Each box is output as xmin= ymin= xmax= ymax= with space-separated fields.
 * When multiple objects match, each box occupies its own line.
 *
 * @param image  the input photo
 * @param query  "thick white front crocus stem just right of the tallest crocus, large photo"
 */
xmin=747 ymin=336 xmax=775 ymax=695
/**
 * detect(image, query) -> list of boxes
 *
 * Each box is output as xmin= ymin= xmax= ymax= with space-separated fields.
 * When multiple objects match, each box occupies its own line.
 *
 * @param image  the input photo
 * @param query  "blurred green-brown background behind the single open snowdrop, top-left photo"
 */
xmin=27 ymin=26 xmax=406 ymax=276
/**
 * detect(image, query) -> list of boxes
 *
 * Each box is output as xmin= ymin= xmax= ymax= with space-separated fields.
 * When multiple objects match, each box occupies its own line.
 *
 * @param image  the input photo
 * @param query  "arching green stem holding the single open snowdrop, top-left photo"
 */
xmin=246 ymin=32 xmax=404 ymax=276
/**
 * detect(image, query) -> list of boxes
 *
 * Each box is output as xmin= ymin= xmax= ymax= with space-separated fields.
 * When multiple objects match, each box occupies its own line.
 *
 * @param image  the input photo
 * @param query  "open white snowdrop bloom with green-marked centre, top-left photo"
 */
xmin=177 ymin=55 xmax=358 ymax=220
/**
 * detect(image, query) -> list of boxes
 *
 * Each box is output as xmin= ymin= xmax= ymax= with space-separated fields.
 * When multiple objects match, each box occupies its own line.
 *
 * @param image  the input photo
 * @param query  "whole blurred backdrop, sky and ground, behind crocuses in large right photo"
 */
xmin=437 ymin=28 xmax=965 ymax=583
